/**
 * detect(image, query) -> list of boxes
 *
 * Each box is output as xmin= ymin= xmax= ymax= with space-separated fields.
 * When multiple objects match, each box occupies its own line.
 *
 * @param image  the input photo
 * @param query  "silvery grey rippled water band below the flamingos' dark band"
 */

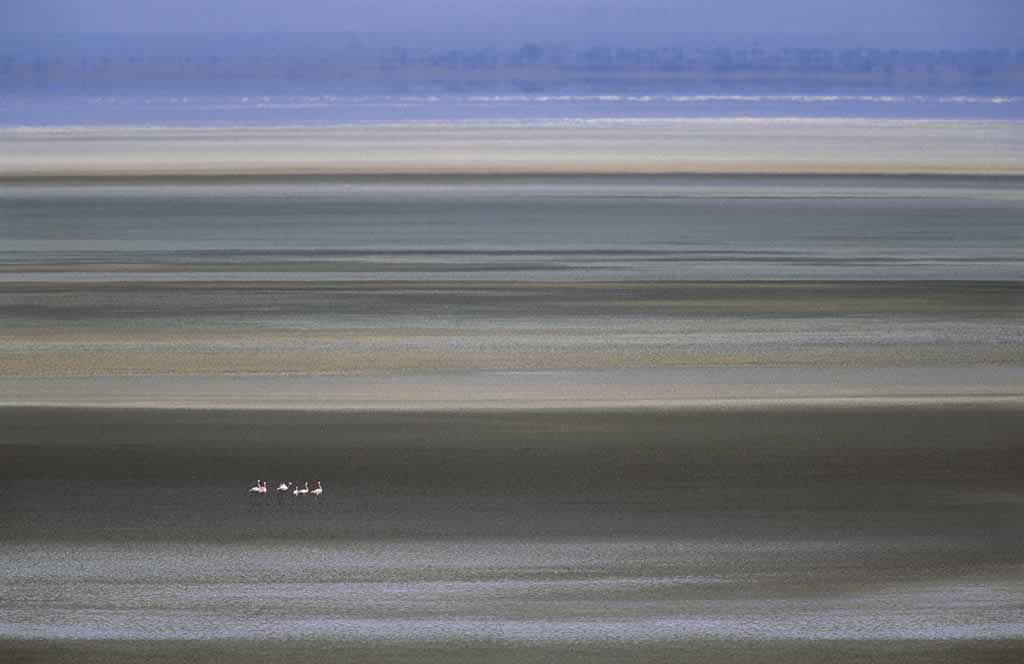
xmin=0 ymin=538 xmax=1024 ymax=641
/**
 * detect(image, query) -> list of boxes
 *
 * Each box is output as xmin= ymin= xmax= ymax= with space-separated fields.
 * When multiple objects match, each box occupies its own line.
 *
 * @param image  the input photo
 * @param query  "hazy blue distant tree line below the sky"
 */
xmin=0 ymin=36 xmax=1024 ymax=91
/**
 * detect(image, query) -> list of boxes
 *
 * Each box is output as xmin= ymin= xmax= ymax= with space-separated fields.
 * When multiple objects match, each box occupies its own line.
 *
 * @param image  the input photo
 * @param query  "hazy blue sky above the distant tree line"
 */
xmin=6 ymin=0 xmax=1024 ymax=48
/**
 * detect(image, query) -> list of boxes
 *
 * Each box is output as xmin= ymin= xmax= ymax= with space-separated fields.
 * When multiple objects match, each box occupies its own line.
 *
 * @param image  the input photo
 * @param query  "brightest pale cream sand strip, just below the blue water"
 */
xmin=6 ymin=119 xmax=1024 ymax=178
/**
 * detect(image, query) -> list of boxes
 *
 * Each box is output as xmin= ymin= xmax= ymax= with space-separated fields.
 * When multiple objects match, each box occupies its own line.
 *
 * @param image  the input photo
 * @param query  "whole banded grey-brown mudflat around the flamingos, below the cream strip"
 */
xmin=0 ymin=167 xmax=1024 ymax=661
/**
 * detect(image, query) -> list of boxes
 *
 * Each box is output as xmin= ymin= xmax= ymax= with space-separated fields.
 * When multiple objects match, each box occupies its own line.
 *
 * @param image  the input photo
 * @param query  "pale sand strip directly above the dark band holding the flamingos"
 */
xmin=0 ymin=367 xmax=1024 ymax=411
